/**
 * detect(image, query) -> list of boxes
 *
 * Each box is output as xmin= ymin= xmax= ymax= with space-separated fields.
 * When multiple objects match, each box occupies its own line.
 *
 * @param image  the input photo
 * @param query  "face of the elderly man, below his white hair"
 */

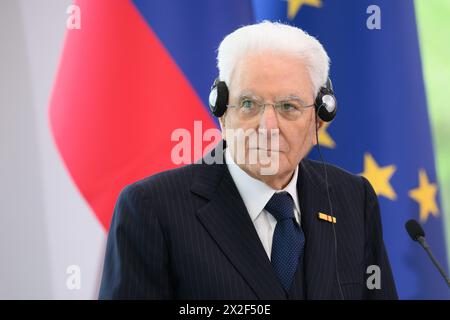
xmin=220 ymin=51 xmax=316 ymax=188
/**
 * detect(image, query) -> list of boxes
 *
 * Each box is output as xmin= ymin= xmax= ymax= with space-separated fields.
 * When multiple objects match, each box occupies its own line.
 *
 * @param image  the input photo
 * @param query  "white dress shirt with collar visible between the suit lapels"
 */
xmin=225 ymin=148 xmax=300 ymax=259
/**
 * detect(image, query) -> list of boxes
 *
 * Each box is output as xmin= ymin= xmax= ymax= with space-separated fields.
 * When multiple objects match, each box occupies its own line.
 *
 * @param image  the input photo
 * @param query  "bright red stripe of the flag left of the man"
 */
xmin=49 ymin=0 xmax=215 ymax=229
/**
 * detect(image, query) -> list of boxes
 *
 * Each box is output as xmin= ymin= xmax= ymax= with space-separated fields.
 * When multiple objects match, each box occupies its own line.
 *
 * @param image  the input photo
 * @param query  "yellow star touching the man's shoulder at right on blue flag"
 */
xmin=361 ymin=153 xmax=397 ymax=200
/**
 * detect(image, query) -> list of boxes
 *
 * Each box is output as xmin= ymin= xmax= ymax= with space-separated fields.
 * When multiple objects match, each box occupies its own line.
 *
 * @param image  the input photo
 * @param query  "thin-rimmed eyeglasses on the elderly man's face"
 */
xmin=228 ymin=97 xmax=314 ymax=120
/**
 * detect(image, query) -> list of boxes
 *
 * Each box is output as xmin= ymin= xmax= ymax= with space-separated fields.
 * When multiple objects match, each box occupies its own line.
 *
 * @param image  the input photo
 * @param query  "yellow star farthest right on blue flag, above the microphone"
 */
xmin=408 ymin=169 xmax=439 ymax=222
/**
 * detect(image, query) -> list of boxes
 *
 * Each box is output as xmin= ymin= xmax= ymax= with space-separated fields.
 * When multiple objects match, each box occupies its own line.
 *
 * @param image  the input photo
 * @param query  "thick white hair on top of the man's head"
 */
xmin=217 ymin=21 xmax=330 ymax=95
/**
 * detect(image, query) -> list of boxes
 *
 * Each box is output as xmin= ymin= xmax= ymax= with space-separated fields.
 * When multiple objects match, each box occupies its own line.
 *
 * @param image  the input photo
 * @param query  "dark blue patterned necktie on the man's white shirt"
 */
xmin=265 ymin=192 xmax=305 ymax=292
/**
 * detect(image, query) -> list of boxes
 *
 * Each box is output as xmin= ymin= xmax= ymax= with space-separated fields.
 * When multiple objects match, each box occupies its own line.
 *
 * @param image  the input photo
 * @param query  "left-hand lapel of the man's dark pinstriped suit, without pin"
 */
xmin=191 ymin=146 xmax=286 ymax=299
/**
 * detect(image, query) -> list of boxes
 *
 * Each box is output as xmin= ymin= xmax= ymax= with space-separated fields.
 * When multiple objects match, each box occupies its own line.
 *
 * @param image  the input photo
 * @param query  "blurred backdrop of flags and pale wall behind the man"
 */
xmin=0 ymin=0 xmax=450 ymax=299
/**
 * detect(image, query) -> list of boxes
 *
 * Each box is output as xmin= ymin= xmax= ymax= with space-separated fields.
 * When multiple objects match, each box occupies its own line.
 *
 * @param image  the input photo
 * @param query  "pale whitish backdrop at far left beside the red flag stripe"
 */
xmin=0 ymin=0 xmax=106 ymax=299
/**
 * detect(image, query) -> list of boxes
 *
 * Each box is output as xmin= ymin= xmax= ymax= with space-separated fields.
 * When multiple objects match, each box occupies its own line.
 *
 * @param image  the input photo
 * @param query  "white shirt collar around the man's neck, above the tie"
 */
xmin=225 ymin=148 xmax=300 ymax=221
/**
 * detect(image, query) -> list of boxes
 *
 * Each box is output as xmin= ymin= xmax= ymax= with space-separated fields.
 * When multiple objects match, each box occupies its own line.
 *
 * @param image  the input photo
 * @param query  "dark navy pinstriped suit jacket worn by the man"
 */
xmin=99 ymin=144 xmax=397 ymax=299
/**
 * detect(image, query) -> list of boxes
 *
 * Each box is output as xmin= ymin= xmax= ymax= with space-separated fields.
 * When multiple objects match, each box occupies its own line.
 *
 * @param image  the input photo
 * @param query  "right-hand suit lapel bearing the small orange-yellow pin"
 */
xmin=297 ymin=159 xmax=336 ymax=300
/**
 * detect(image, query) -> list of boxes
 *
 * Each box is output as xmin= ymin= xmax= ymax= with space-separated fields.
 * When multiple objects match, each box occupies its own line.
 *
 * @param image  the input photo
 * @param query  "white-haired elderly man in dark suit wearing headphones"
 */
xmin=100 ymin=22 xmax=397 ymax=299
